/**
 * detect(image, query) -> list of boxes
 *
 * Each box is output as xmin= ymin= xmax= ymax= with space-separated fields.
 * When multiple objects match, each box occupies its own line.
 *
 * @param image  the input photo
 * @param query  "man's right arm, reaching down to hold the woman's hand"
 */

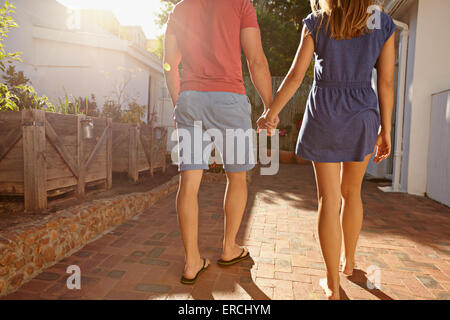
xmin=241 ymin=28 xmax=273 ymax=110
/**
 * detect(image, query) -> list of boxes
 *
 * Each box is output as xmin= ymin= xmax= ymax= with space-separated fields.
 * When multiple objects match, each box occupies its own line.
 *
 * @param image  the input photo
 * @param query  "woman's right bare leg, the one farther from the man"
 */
xmin=341 ymin=155 xmax=371 ymax=275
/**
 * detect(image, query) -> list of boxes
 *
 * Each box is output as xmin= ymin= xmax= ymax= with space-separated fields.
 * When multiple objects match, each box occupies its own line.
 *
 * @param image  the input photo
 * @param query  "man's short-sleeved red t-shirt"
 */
xmin=166 ymin=0 xmax=259 ymax=94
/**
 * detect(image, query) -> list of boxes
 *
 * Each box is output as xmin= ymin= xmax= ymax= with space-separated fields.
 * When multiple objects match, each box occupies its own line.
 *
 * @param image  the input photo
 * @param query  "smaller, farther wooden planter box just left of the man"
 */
xmin=113 ymin=123 xmax=167 ymax=182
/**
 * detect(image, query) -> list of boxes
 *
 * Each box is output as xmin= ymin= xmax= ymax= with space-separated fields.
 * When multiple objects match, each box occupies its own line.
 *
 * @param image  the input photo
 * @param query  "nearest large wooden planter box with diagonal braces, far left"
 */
xmin=0 ymin=110 xmax=112 ymax=212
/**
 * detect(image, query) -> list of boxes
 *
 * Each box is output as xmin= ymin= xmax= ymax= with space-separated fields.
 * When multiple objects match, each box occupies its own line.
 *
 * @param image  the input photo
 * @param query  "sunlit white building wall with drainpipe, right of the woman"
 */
xmin=401 ymin=0 xmax=450 ymax=195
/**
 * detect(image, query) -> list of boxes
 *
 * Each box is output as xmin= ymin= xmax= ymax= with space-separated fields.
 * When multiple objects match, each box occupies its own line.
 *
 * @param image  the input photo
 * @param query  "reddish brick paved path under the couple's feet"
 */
xmin=1 ymin=166 xmax=450 ymax=300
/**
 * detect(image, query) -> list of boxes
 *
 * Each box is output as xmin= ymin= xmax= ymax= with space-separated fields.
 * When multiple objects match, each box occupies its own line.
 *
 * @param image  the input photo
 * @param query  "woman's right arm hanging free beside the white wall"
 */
xmin=374 ymin=34 xmax=395 ymax=163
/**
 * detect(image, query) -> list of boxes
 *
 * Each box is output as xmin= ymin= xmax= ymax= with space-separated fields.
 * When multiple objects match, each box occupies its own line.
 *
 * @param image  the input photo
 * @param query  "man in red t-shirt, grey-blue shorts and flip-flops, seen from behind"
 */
xmin=164 ymin=0 xmax=272 ymax=284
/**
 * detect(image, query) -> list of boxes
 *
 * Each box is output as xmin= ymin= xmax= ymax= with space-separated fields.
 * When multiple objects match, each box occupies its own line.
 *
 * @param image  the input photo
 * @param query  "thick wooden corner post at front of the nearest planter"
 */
xmin=22 ymin=110 xmax=47 ymax=213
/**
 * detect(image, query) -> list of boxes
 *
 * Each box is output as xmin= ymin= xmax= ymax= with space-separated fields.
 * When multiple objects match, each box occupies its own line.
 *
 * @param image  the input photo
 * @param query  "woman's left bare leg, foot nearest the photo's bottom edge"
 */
xmin=314 ymin=162 xmax=342 ymax=300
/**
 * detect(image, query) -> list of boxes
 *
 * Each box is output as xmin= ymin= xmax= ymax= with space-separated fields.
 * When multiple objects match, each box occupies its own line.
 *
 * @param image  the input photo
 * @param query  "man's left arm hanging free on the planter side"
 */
xmin=164 ymin=34 xmax=181 ymax=107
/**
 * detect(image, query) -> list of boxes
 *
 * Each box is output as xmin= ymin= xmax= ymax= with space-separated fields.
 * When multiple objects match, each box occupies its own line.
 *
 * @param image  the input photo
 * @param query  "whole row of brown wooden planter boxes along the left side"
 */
xmin=0 ymin=110 xmax=167 ymax=212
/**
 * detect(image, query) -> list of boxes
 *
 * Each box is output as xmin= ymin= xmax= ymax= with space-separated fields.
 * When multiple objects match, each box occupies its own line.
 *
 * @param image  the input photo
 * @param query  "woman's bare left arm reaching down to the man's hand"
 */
xmin=265 ymin=27 xmax=314 ymax=127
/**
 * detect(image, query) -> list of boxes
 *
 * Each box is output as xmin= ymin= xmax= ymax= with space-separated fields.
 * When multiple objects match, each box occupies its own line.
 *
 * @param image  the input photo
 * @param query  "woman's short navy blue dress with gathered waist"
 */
xmin=296 ymin=12 xmax=396 ymax=162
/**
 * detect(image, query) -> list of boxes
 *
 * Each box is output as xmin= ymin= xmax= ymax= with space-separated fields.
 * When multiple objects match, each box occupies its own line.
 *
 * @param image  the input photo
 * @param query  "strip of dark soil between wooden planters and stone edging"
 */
xmin=0 ymin=165 xmax=178 ymax=232
